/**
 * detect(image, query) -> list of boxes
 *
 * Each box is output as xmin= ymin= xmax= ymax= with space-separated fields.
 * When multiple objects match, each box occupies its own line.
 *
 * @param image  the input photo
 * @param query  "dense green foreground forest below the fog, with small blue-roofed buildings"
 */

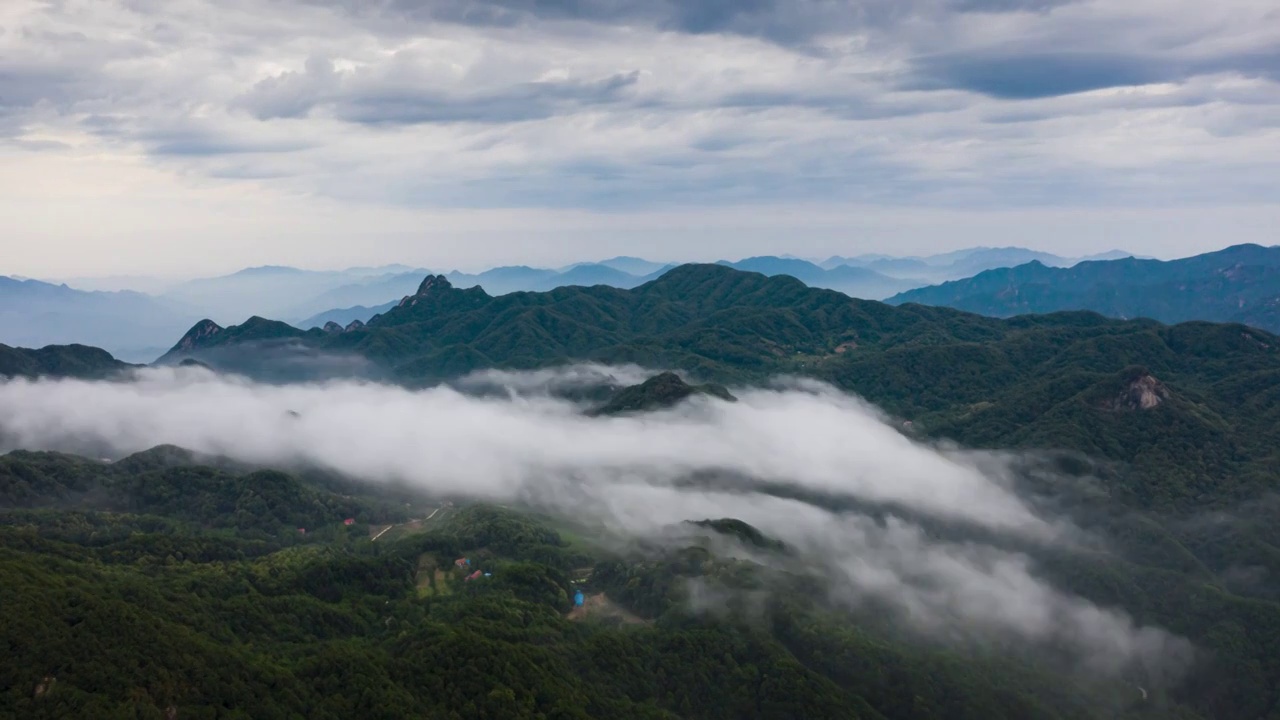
xmin=0 ymin=448 xmax=1280 ymax=720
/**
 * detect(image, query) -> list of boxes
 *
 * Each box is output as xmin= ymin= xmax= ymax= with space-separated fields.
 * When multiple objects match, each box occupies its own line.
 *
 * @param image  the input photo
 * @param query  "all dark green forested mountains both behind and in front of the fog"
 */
xmin=0 ymin=264 xmax=1280 ymax=720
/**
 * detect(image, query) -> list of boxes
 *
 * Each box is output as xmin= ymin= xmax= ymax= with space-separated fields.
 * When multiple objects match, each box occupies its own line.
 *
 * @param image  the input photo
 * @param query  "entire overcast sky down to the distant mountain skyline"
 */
xmin=0 ymin=0 xmax=1280 ymax=275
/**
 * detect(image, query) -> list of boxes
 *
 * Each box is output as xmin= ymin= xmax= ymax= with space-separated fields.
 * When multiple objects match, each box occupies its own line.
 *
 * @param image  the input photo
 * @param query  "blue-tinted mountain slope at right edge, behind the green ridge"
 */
xmin=888 ymin=245 xmax=1280 ymax=332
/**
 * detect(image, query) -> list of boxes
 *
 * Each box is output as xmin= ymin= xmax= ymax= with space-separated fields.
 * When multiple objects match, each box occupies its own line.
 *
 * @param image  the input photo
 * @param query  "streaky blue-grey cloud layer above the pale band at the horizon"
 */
xmin=0 ymin=0 xmax=1280 ymax=263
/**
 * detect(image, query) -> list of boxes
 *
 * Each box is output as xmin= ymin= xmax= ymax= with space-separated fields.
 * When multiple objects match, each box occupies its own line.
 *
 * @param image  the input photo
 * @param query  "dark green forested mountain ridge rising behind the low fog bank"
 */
xmin=152 ymin=265 xmax=1280 ymax=509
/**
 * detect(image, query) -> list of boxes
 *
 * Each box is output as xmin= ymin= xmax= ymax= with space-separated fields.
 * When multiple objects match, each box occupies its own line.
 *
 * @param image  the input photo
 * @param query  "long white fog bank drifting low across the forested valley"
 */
xmin=0 ymin=368 xmax=1189 ymax=671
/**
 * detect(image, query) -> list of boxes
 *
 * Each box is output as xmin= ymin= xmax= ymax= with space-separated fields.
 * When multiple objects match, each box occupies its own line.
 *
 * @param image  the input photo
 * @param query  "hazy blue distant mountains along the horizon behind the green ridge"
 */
xmin=0 ymin=247 xmax=1277 ymax=361
